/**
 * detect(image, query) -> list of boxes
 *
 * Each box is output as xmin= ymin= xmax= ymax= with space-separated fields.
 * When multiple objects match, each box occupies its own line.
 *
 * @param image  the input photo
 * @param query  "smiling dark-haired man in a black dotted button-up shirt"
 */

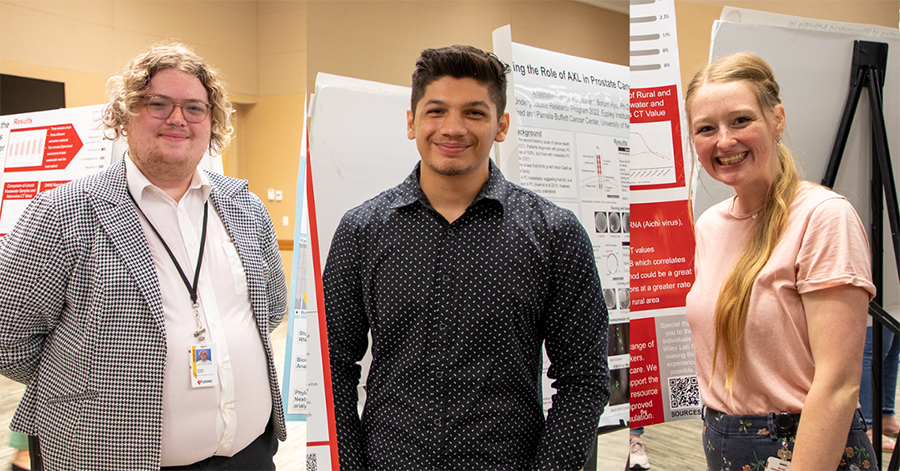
xmin=324 ymin=46 xmax=609 ymax=471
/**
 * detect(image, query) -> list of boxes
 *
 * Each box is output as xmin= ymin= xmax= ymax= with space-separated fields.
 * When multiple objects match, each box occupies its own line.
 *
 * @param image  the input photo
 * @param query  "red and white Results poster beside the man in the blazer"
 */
xmin=0 ymin=105 xmax=113 ymax=235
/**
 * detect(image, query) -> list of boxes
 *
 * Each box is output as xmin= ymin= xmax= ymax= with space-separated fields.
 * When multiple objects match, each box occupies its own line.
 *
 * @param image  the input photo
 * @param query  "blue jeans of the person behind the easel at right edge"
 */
xmin=859 ymin=327 xmax=900 ymax=427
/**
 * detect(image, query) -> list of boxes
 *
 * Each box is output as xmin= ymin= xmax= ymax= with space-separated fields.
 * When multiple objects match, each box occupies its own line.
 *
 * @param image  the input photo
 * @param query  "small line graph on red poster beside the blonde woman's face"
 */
xmin=629 ymin=121 xmax=675 ymax=185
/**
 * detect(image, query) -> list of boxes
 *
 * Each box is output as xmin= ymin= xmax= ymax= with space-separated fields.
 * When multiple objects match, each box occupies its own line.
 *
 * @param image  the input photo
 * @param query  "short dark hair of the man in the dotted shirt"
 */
xmin=410 ymin=46 xmax=509 ymax=118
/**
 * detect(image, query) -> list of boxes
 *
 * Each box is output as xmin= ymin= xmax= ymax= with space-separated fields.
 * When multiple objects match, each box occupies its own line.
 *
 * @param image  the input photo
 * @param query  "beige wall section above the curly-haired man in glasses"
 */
xmin=0 ymin=0 xmax=258 ymax=99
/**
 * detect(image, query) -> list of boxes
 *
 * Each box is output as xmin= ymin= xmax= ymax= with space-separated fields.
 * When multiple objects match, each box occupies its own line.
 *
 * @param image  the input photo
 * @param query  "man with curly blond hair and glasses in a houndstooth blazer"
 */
xmin=0 ymin=42 xmax=287 ymax=471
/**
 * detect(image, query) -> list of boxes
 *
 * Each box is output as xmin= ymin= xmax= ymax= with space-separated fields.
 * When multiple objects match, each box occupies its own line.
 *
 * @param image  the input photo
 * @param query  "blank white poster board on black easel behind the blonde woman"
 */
xmin=694 ymin=8 xmax=900 ymax=306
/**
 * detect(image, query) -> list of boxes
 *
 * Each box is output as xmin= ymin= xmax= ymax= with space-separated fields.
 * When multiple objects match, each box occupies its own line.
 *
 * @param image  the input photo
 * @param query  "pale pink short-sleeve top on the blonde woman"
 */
xmin=686 ymin=182 xmax=875 ymax=415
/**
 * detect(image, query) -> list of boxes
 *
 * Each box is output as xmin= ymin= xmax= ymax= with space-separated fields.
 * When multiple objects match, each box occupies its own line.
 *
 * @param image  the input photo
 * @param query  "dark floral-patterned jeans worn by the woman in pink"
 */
xmin=703 ymin=408 xmax=878 ymax=471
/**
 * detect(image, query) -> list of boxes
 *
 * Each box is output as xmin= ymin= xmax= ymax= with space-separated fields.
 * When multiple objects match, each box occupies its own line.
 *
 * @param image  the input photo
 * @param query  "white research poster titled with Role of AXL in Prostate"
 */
xmin=494 ymin=28 xmax=631 ymax=426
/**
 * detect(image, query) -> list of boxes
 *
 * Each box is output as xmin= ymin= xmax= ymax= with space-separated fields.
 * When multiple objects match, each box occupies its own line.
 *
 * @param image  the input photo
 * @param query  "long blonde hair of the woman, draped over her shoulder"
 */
xmin=685 ymin=53 xmax=799 ymax=394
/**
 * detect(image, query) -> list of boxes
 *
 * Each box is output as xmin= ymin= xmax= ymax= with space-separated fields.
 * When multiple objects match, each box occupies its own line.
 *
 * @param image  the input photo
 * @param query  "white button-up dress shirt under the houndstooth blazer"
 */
xmin=125 ymin=157 xmax=272 ymax=466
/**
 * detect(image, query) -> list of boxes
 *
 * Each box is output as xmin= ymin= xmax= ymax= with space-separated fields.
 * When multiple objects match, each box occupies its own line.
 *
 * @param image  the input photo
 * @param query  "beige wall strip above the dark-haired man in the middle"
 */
xmin=307 ymin=0 xmax=628 ymax=90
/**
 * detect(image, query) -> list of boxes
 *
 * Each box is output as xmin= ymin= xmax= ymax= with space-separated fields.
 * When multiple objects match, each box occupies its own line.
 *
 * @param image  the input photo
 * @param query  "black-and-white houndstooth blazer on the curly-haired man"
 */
xmin=0 ymin=160 xmax=287 ymax=471
